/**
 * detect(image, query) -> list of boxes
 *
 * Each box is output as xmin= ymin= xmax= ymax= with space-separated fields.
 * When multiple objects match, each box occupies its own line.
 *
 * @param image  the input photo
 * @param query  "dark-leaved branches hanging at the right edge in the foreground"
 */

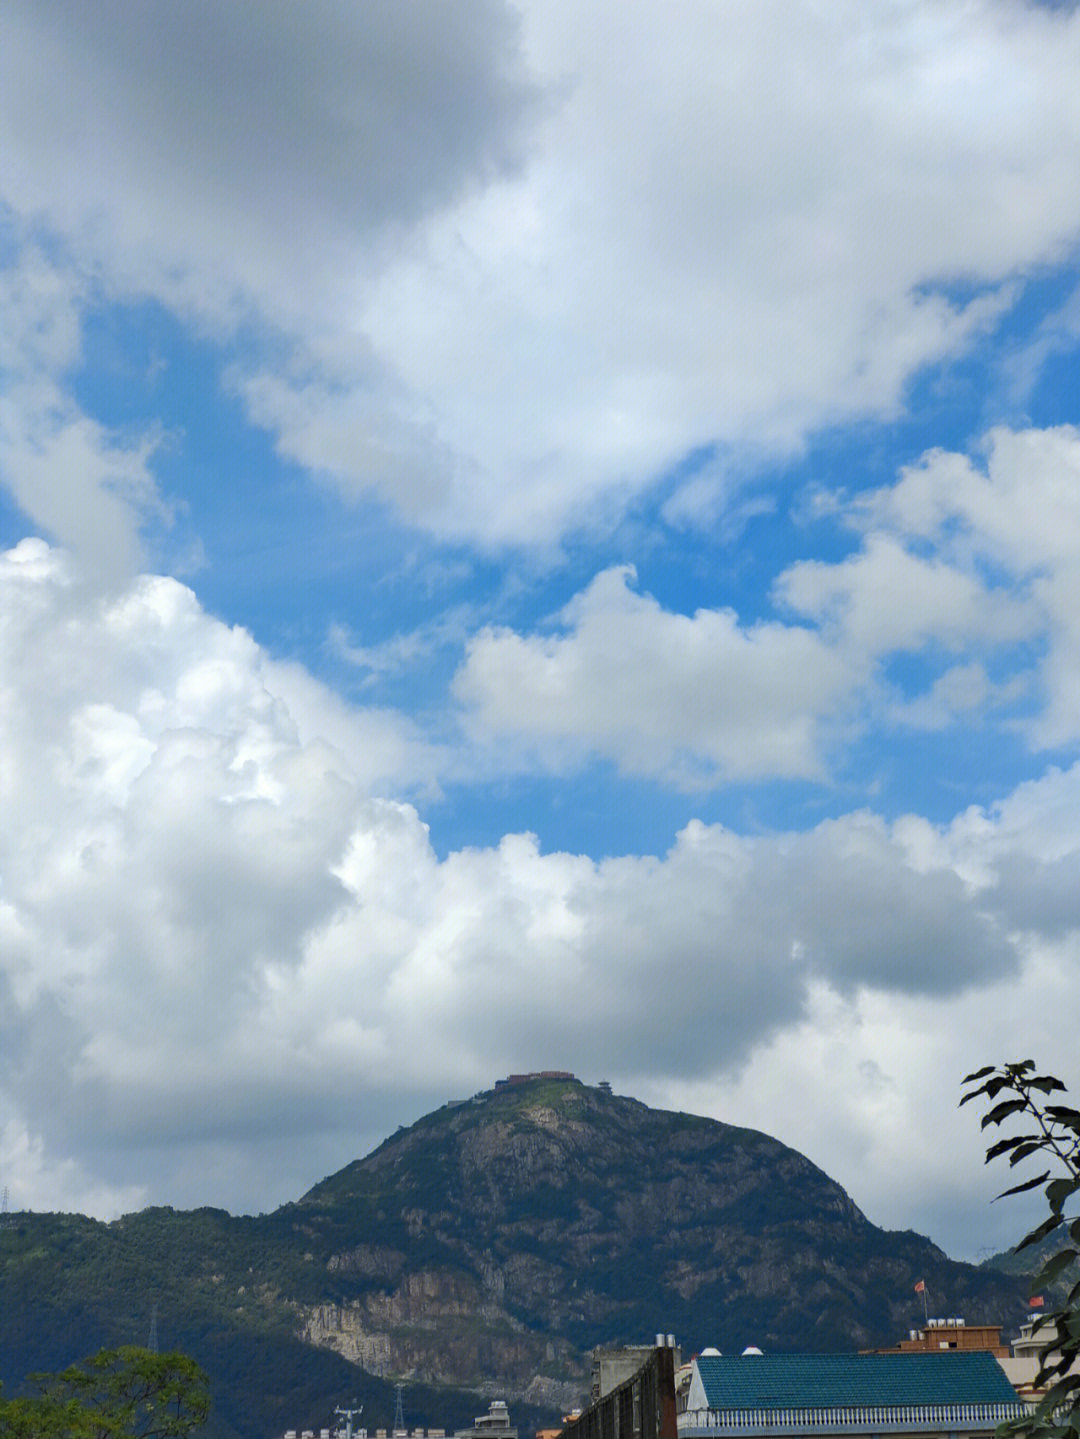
xmin=961 ymin=1059 xmax=1080 ymax=1439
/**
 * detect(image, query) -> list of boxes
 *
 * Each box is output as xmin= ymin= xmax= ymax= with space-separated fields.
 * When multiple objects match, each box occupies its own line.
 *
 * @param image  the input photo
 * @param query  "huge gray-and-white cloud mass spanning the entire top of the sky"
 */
xmin=0 ymin=0 xmax=1080 ymax=545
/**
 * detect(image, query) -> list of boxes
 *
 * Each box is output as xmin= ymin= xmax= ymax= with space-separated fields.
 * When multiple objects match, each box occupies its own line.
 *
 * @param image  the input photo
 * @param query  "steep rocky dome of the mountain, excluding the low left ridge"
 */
xmin=289 ymin=1081 xmax=1024 ymax=1402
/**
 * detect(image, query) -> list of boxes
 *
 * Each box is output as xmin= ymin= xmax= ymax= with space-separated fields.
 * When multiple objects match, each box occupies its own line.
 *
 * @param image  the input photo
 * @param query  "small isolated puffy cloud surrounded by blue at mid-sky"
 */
xmin=454 ymin=568 xmax=860 ymax=786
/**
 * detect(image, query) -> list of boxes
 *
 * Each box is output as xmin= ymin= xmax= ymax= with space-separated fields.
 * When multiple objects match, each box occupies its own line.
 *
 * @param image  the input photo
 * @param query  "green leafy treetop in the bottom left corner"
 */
xmin=0 ymin=1347 xmax=210 ymax=1439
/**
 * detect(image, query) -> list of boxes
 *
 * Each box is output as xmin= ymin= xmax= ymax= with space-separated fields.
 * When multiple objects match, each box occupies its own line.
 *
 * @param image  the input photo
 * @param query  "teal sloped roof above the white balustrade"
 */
xmin=697 ymin=1350 xmax=1017 ymax=1409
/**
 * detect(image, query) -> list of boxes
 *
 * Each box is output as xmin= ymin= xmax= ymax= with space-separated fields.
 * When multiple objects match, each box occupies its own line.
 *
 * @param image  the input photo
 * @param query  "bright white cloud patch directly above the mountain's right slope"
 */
xmin=647 ymin=932 xmax=1080 ymax=1262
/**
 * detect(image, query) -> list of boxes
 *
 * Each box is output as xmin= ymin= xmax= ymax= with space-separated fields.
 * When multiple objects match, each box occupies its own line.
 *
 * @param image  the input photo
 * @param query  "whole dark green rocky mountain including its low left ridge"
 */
xmin=0 ymin=1078 xmax=1027 ymax=1439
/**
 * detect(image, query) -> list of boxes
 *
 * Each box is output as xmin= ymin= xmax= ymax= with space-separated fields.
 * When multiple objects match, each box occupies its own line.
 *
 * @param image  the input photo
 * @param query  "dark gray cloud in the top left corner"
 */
xmin=4 ymin=0 xmax=538 ymax=304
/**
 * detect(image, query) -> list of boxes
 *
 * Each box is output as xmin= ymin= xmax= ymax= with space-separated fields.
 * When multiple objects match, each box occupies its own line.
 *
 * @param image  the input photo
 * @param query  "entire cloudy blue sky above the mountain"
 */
xmin=0 ymin=0 xmax=1080 ymax=1255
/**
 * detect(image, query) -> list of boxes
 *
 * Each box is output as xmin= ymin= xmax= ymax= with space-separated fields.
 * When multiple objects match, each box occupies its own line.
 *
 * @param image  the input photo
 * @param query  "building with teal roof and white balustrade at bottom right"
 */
xmin=679 ymin=1350 xmax=1028 ymax=1439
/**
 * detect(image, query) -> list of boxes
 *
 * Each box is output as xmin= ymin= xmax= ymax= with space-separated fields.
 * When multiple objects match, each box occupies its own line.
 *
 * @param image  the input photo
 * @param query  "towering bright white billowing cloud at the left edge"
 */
xmin=0 ymin=541 xmax=442 ymax=1179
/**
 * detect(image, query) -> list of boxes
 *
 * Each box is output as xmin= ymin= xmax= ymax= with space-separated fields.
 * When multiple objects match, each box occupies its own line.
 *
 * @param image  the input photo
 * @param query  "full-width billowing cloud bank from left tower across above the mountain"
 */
xmin=0 ymin=541 xmax=1080 ymax=1237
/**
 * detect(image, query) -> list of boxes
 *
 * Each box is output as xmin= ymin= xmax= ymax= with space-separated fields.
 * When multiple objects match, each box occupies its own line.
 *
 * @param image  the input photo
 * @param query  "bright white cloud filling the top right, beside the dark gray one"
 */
xmin=342 ymin=4 xmax=1080 ymax=543
